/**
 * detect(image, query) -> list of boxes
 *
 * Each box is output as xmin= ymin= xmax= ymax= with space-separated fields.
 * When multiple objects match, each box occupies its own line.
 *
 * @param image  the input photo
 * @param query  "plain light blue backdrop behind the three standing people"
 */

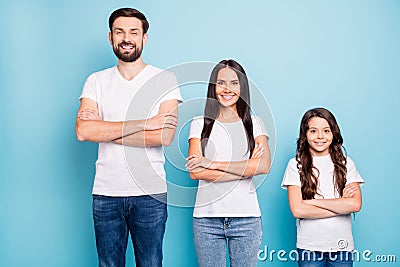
xmin=0 ymin=0 xmax=400 ymax=267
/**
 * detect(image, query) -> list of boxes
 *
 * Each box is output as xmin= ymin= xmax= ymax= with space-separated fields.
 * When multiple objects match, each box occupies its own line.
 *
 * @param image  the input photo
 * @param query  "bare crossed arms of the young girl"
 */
xmin=288 ymin=182 xmax=362 ymax=219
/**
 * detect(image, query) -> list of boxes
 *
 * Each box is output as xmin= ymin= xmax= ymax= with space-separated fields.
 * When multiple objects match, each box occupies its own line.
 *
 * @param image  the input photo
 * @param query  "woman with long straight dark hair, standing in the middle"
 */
xmin=186 ymin=60 xmax=270 ymax=267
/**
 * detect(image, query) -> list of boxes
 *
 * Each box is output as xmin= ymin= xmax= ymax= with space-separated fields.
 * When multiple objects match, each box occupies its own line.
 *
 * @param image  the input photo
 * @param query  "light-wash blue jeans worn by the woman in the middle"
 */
xmin=193 ymin=217 xmax=262 ymax=267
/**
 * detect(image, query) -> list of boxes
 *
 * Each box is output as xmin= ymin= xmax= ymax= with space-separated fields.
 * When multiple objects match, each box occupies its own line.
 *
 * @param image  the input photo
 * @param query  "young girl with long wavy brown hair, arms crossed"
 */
xmin=282 ymin=108 xmax=364 ymax=267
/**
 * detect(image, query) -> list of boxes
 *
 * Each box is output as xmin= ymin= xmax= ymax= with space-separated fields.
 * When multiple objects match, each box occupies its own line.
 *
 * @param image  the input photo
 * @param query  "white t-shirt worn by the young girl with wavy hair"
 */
xmin=281 ymin=154 xmax=364 ymax=252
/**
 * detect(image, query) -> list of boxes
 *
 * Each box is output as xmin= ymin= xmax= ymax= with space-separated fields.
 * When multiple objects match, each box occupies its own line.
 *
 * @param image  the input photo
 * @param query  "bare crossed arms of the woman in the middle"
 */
xmin=186 ymin=135 xmax=271 ymax=182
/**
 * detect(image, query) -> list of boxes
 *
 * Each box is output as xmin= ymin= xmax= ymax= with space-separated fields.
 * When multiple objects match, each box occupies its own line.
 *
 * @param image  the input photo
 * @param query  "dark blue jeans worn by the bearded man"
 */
xmin=93 ymin=193 xmax=167 ymax=267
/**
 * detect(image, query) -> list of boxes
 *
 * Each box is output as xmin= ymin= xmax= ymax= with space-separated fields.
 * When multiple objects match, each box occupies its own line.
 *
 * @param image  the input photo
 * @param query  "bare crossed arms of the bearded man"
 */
xmin=75 ymin=98 xmax=178 ymax=147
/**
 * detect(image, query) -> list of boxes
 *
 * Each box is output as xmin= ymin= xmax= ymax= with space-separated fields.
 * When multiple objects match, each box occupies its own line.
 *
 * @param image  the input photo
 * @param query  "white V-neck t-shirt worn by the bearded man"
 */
xmin=80 ymin=65 xmax=182 ymax=196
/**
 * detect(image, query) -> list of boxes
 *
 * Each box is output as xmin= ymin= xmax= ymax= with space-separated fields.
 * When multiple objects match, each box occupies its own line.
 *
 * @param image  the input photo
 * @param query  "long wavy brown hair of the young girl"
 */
xmin=296 ymin=108 xmax=347 ymax=200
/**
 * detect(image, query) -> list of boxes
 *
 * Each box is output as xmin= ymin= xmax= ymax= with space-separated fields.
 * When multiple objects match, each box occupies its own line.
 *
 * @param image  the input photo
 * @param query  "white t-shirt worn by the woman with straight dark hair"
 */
xmin=188 ymin=116 xmax=268 ymax=217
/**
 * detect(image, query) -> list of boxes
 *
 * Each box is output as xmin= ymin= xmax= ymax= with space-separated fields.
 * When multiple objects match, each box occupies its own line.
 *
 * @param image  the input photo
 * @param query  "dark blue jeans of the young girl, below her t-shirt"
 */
xmin=297 ymin=248 xmax=353 ymax=267
